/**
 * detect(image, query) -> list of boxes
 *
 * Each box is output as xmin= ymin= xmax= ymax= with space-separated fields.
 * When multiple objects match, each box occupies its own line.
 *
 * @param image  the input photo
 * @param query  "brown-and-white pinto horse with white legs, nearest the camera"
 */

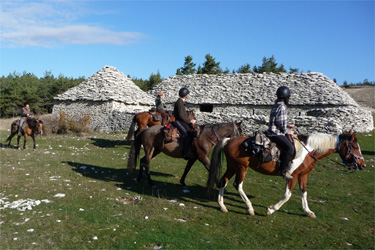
xmin=207 ymin=130 xmax=366 ymax=218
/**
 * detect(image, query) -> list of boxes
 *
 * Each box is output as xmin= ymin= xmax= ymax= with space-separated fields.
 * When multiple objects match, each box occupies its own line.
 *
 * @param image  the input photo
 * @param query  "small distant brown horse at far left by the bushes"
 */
xmin=6 ymin=118 xmax=43 ymax=149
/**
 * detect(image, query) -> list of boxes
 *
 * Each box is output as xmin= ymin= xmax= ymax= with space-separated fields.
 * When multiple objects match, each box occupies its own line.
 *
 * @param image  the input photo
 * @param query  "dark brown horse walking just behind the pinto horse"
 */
xmin=128 ymin=122 xmax=242 ymax=188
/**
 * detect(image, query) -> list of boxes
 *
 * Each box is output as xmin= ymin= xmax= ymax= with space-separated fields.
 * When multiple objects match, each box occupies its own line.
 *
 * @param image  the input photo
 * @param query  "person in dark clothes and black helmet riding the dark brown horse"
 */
xmin=173 ymin=88 xmax=196 ymax=159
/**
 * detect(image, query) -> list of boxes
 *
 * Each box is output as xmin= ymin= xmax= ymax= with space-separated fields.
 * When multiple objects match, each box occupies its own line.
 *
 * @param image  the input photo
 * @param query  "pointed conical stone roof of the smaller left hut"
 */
xmin=54 ymin=66 xmax=155 ymax=105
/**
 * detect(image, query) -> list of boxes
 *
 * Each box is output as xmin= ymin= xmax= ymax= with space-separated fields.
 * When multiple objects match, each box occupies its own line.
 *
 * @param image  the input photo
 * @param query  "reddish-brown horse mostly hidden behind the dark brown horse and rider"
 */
xmin=125 ymin=110 xmax=180 ymax=141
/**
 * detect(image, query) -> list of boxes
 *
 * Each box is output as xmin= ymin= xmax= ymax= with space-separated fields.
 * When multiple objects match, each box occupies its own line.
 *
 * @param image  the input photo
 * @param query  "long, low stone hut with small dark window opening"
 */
xmin=149 ymin=73 xmax=374 ymax=134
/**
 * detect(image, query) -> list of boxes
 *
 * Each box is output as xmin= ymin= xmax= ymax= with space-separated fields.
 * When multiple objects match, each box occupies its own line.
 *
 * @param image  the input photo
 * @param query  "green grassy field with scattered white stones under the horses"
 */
xmin=0 ymin=128 xmax=375 ymax=249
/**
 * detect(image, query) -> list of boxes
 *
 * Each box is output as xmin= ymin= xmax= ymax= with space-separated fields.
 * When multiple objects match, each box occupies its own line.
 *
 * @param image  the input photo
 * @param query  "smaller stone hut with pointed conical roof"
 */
xmin=52 ymin=66 xmax=154 ymax=131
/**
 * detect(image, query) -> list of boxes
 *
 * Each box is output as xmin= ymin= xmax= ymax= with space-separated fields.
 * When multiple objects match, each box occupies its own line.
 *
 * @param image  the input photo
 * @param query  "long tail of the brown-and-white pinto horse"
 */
xmin=207 ymin=138 xmax=230 ymax=193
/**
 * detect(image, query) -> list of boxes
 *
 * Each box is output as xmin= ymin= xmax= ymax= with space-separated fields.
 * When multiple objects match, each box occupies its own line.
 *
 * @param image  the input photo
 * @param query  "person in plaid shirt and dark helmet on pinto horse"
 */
xmin=267 ymin=86 xmax=294 ymax=180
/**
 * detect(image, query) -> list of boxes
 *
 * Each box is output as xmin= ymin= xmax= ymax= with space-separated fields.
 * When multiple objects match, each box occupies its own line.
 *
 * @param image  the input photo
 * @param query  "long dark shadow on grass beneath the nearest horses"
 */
xmin=63 ymin=161 xmax=305 ymax=216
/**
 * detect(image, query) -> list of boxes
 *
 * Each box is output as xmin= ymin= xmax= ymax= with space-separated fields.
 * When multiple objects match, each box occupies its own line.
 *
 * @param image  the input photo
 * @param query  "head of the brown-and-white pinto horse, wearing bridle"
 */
xmin=338 ymin=130 xmax=366 ymax=170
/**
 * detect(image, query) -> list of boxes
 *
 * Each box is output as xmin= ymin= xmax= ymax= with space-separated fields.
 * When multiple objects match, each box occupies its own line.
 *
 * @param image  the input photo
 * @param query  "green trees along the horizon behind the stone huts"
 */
xmin=0 ymin=54 xmax=375 ymax=118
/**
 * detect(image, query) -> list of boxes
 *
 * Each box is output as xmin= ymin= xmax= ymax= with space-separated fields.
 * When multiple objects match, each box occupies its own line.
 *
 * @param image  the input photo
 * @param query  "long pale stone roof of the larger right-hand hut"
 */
xmin=148 ymin=73 xmax=359 ymax=106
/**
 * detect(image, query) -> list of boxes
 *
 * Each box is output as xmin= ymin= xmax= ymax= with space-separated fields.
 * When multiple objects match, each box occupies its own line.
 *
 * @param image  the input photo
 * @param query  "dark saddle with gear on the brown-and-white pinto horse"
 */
xmin=243 ymin=131 xmax=302 ymax=163
